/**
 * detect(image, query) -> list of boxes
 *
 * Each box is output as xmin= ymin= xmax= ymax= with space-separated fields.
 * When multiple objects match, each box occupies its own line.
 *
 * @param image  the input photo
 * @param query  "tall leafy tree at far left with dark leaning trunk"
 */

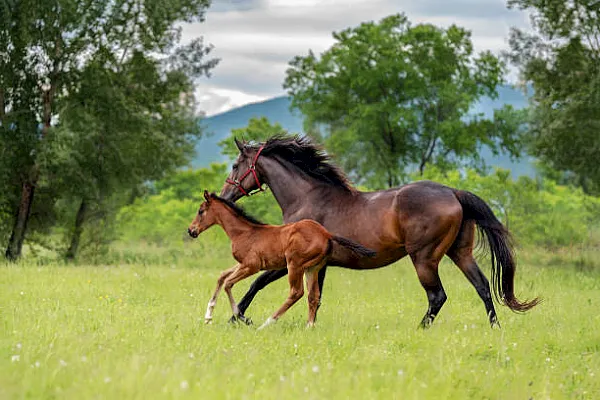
xmin=0 ymin=0 xmax=215 ymax=259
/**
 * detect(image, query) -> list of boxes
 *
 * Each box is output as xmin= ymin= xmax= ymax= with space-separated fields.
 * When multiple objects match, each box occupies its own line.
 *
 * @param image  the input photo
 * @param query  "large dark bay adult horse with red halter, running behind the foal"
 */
xmin=221 ymin=136 xmax=538 ymax=328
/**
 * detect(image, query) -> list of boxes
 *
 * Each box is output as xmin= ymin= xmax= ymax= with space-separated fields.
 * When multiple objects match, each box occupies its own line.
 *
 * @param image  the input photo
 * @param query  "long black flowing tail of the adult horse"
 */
xmin=454 ymin=190 xmax=539 ymax=312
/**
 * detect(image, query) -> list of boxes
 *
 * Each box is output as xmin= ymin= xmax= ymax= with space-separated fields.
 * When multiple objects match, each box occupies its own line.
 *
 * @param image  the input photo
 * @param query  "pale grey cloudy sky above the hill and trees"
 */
xmin=183 ymin=0 xmax=529 ymax=116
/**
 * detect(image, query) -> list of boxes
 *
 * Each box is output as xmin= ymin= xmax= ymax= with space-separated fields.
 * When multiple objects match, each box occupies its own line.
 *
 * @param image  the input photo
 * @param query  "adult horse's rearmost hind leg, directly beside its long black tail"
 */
xmin=448 ymin=223 xmax=500 ymax=327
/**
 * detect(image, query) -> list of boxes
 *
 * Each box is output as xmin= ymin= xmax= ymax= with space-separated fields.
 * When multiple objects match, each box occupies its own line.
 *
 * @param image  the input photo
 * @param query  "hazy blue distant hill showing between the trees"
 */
xmin=192 ymin=86 xmax=535 ymax=177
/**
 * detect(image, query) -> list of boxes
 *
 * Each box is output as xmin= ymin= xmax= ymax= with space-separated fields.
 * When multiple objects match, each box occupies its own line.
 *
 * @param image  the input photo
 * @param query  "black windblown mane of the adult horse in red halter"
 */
xmin=255 ymin=135 xmax=355 ymax=192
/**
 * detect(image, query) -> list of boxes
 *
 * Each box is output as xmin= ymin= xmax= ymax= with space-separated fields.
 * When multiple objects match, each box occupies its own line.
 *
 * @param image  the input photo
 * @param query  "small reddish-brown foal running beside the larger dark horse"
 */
xmin=188 ymin=190 xmax=375 ymax=329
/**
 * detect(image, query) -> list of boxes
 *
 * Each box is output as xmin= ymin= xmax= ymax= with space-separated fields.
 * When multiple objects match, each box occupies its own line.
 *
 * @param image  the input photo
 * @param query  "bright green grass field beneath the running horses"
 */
xmin=0 ymin=252 xmax=600 ymax=399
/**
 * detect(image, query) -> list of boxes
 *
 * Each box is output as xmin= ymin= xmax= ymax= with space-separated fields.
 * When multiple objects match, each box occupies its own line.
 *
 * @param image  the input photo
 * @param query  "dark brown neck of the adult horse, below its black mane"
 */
xmin=259 ymin=157 xmax=352 ymax=217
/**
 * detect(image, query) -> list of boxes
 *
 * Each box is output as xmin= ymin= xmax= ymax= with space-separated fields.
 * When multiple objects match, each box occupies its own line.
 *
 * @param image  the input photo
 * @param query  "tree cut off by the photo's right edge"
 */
xmin=507 ymin=0 xmax=600 ymax=193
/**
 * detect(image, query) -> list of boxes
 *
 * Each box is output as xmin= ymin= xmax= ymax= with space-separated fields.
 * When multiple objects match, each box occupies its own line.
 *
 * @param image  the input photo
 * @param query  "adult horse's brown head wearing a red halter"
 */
xmin=220 ymin=139 xmax=264 ymax=202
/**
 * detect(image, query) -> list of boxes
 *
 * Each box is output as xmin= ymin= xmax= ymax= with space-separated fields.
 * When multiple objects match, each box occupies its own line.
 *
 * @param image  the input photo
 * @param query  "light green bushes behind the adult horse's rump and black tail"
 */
xmin=422 ymin=168 xmax=600 ymax=248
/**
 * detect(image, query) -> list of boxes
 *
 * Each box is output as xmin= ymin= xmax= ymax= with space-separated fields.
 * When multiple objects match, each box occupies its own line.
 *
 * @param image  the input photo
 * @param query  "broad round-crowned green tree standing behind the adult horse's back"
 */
xmin=284 ymin=14 xmax=523 ymax=187
